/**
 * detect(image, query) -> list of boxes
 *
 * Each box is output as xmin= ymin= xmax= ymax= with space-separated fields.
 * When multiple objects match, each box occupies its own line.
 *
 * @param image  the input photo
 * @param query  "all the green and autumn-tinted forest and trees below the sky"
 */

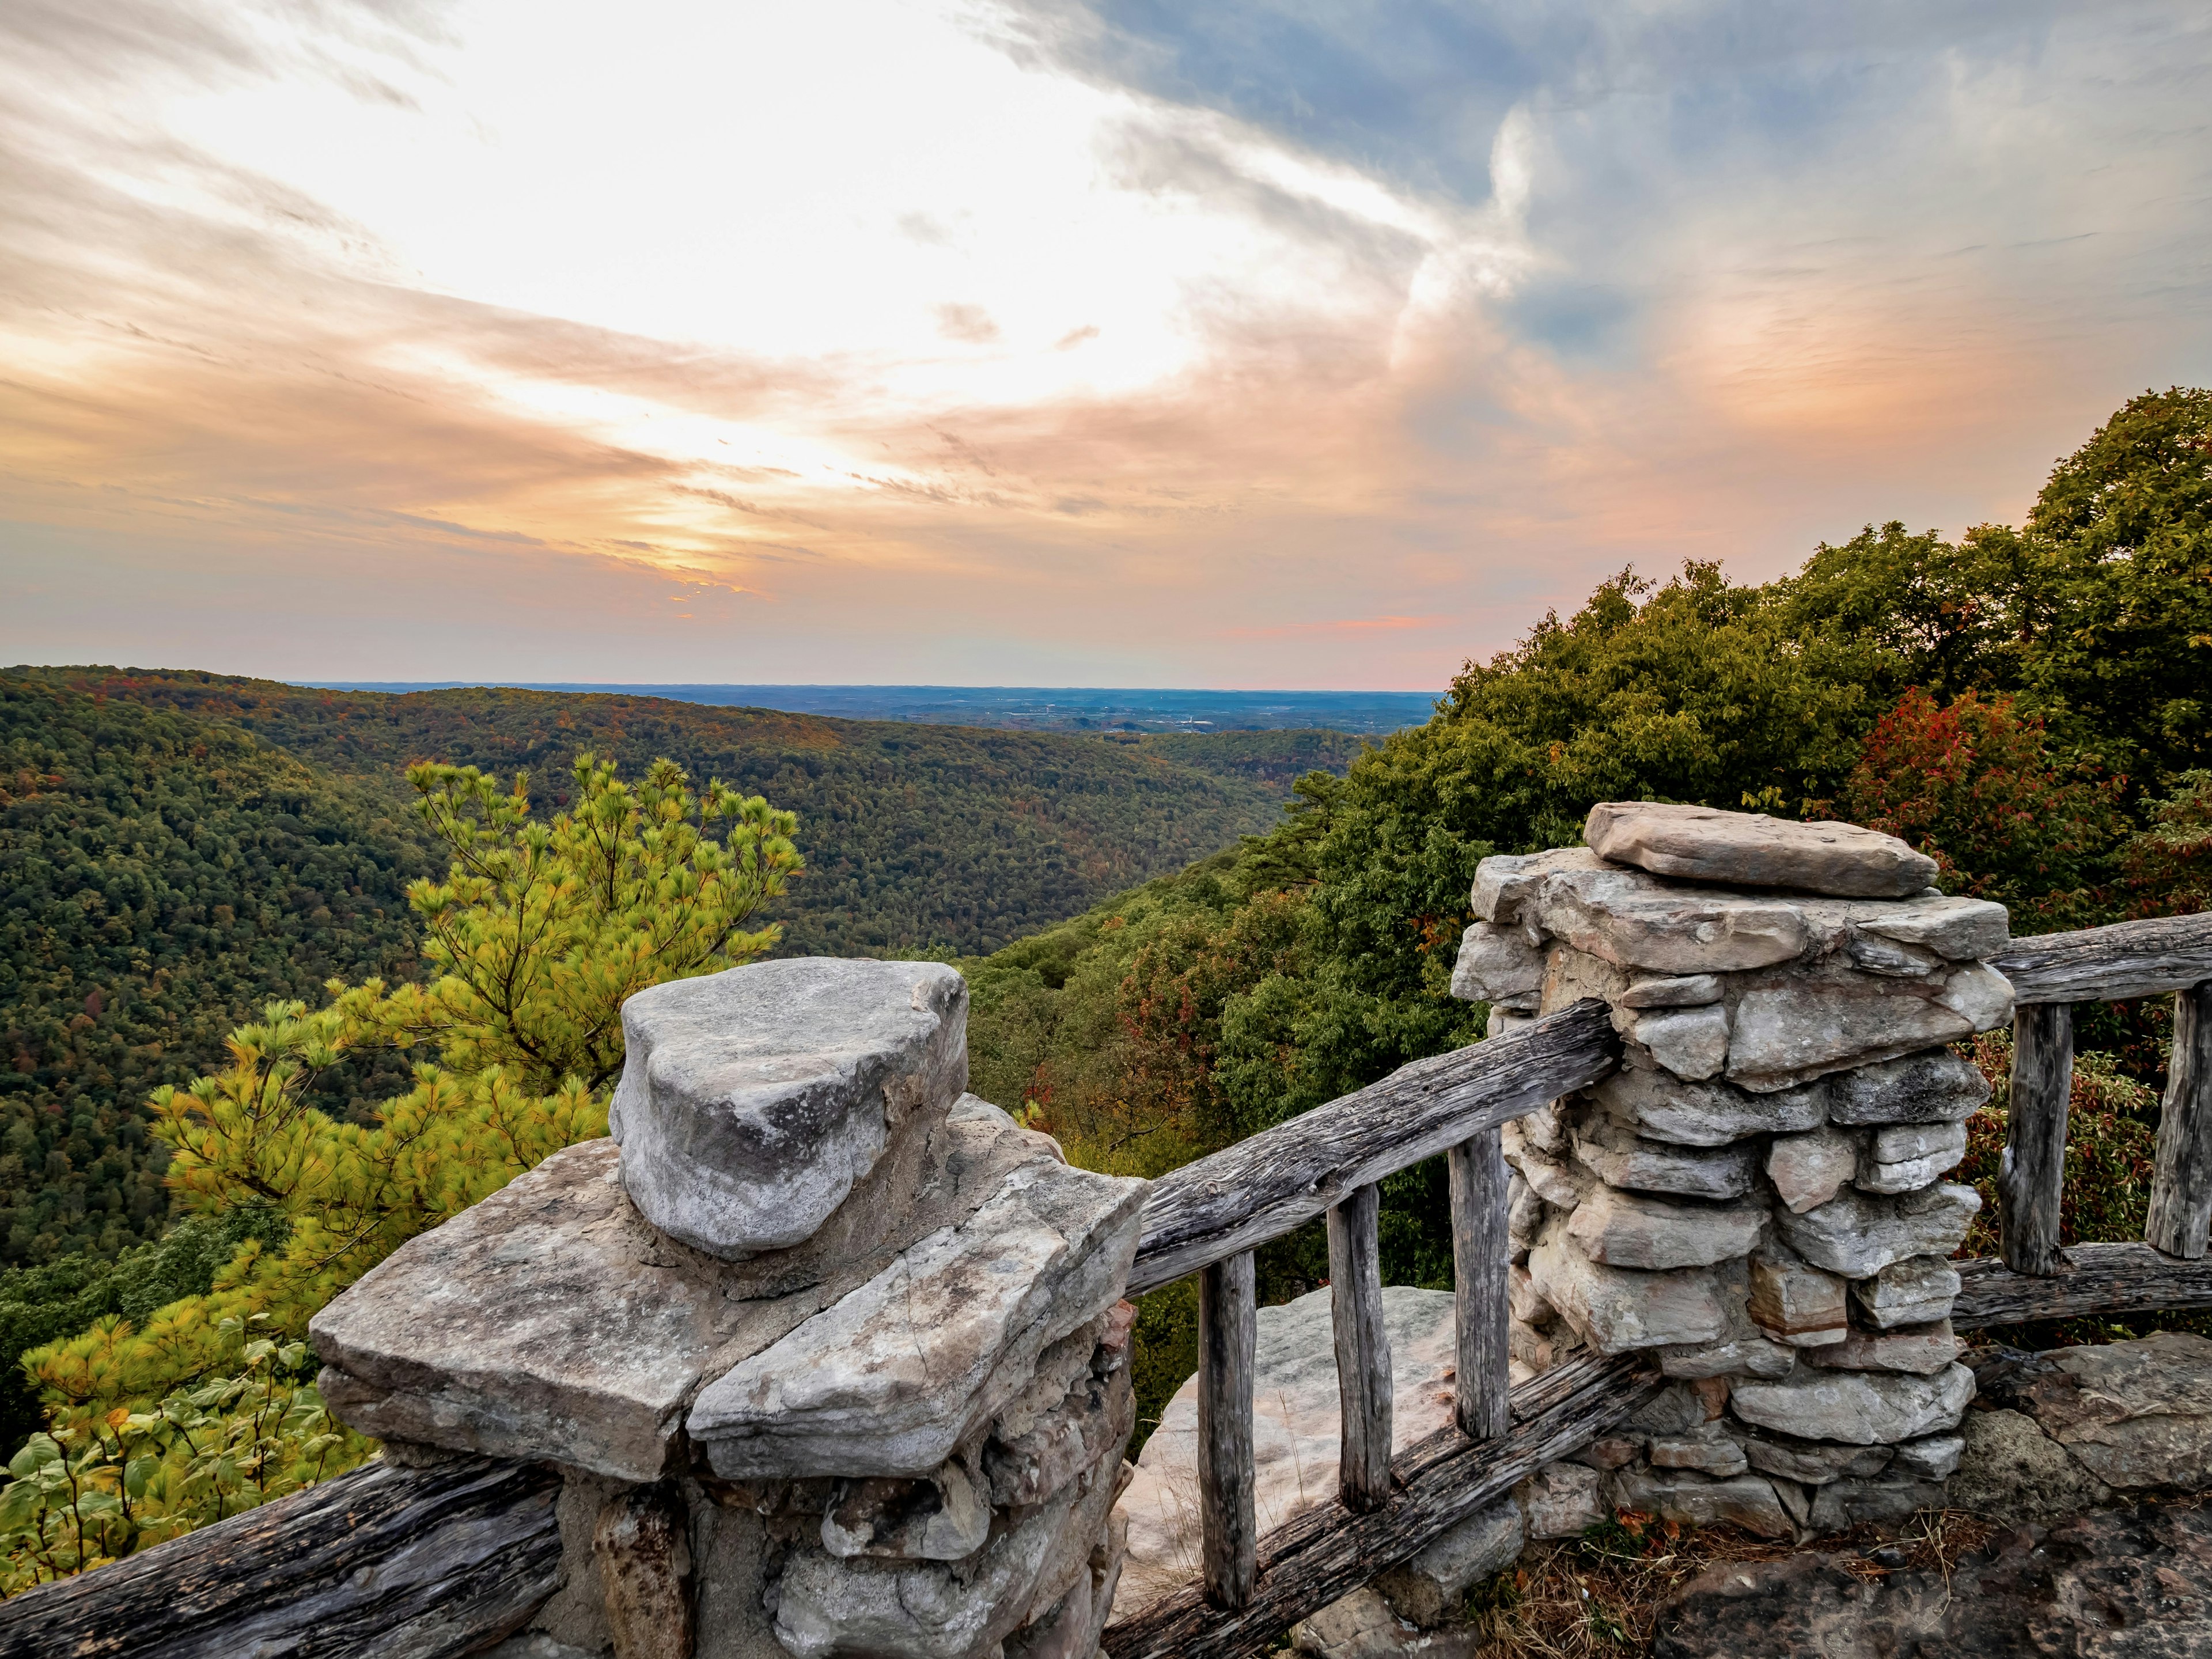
xmin=0 ymin=389 xmax=2212 ymax=1590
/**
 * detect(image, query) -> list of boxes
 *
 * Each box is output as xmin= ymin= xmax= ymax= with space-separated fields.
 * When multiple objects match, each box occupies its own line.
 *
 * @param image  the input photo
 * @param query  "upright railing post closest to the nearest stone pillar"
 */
xmin=1199 ymin=1250 xmax=1259 ymax=1608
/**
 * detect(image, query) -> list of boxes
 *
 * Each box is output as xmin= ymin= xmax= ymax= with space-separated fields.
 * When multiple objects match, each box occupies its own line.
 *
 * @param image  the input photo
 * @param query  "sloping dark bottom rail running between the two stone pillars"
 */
xmin=1104 ymin=1354 xmax=1661 ymax=1659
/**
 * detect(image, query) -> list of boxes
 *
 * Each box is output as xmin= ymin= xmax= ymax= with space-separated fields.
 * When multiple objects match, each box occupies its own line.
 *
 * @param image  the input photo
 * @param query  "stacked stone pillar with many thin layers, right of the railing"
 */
xmin=1453 ymin=803 xmax=2013 ymax=1535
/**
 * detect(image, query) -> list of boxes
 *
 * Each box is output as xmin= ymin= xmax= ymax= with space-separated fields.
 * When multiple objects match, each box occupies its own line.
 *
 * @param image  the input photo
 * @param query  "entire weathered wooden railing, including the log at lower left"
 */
xmin=0 ymin=916 xmax=2212 ymax=1659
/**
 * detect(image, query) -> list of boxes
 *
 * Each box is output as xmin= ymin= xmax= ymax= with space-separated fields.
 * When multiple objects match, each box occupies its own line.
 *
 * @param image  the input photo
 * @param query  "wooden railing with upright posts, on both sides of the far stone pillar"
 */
xmin=1106 ymin=916 xmax=2212 ymax=1659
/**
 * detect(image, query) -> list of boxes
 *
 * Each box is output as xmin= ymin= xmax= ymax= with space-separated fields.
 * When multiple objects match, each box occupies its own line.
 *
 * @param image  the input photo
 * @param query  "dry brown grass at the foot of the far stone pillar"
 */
xmin=1467 ymin=1509 xmax=1993 ymax=1659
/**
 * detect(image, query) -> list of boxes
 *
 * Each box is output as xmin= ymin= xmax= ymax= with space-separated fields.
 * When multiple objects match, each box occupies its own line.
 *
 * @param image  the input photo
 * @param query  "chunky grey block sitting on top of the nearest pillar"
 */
xmin=608 ymin=958 xmax=967 ymax=1261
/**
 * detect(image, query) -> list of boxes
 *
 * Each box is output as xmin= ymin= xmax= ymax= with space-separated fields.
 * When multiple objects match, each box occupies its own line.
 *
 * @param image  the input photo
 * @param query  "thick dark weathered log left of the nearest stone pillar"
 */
xmin=0 ymin=1458 xmax=560 ymax=1659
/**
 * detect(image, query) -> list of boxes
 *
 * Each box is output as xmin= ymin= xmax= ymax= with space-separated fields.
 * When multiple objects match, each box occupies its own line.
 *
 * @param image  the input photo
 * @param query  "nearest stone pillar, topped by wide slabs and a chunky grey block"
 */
xmin=312 ymin=960 xmax=1143 ymax=1659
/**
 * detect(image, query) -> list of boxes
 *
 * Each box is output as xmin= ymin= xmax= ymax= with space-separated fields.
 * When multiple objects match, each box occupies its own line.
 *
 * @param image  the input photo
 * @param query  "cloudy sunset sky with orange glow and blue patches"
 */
xmin=0 ymin=0 xmax=2212 ymax=690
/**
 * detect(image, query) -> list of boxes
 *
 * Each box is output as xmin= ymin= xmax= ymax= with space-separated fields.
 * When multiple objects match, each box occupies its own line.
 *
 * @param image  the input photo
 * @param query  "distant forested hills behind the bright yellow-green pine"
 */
xmin=0 ymin=668 xmax=1361 ymax=1265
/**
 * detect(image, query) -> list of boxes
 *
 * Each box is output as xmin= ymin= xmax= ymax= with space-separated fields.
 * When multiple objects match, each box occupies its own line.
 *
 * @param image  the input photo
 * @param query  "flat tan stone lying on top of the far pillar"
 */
xmin=1584 ymin=801 xmax=1936 ymax=898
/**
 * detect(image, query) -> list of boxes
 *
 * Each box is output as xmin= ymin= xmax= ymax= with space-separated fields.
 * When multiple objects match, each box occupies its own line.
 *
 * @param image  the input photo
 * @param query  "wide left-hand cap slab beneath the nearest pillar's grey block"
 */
xmin=310 ymin=1097 xmax=1059 ymax=1482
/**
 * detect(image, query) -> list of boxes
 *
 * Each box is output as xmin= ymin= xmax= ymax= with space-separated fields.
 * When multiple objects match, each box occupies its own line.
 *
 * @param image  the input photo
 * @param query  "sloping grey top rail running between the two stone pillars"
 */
xmin=1128 ymin=1000 xmax=1622 ymax=1296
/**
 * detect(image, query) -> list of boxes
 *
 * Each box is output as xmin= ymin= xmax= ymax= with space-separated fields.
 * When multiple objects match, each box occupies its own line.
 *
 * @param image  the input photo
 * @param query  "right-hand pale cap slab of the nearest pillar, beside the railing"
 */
xmin=685 ymin=1164 xmax=1143 ymax=1480
